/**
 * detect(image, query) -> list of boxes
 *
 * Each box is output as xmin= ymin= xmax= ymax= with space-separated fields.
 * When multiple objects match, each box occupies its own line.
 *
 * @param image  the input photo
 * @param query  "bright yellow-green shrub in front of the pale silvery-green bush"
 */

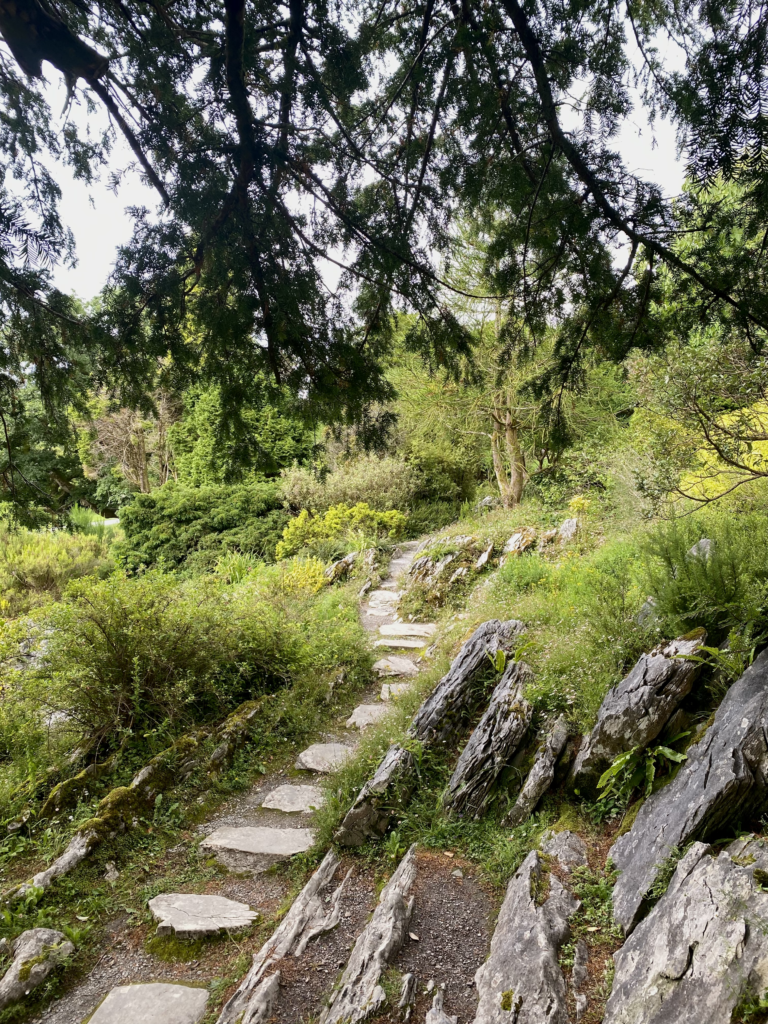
xmin=276 ymin=502 xmax=407 ymax=558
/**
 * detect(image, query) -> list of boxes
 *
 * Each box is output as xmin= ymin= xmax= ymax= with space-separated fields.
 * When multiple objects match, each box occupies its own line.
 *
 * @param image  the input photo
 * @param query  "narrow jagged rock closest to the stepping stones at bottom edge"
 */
xmin=216 ymin=850 xmax=350 ymax=1024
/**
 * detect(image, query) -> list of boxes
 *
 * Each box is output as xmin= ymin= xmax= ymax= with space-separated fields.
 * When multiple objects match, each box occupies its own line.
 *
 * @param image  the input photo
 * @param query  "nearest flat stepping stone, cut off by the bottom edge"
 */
xmin=89 ymin=983 xmax=208 ymax=1024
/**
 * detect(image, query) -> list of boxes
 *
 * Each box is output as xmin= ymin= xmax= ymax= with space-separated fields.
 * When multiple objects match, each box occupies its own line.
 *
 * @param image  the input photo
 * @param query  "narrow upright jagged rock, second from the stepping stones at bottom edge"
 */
xmin=319 ymin=845 xmax=416 ymax=1024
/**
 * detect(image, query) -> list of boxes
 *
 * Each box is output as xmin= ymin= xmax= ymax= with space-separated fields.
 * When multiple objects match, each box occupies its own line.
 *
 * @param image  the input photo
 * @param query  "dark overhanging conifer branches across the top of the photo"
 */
xmin=0 ymin=0 xmax=768 ymax=468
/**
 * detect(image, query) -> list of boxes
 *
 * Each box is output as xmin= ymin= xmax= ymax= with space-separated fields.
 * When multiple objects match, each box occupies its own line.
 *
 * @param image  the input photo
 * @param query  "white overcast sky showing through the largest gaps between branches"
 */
xmin=46 ymin=66 xmax=683 ymax=299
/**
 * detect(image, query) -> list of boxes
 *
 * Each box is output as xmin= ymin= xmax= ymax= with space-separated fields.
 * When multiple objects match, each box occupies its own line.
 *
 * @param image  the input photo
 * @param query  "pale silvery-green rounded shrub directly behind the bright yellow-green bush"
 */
xmin=280 ymin=456 xmax=420 ymax=512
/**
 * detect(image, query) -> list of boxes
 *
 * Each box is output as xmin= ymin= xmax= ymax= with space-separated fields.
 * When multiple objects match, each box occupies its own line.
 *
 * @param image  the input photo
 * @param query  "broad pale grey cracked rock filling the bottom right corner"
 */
xmin=603 ymin=841 xmax=768 ymax=1024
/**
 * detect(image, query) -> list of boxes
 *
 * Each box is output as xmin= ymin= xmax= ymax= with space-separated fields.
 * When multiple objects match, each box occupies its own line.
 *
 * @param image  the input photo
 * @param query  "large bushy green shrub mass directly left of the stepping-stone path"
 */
xmin=0 ymin=565 xmax=370 ymax=765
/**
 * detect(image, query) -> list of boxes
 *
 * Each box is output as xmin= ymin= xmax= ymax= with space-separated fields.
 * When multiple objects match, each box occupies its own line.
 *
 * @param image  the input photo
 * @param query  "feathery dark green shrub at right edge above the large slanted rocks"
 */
xmin=647 ymin=509 xmax=768 ymax=644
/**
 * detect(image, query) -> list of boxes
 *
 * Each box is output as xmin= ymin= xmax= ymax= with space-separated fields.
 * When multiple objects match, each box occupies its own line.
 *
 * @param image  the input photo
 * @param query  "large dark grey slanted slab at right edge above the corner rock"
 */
xmin=609 ymin=651 xmax=768 ymax=932
